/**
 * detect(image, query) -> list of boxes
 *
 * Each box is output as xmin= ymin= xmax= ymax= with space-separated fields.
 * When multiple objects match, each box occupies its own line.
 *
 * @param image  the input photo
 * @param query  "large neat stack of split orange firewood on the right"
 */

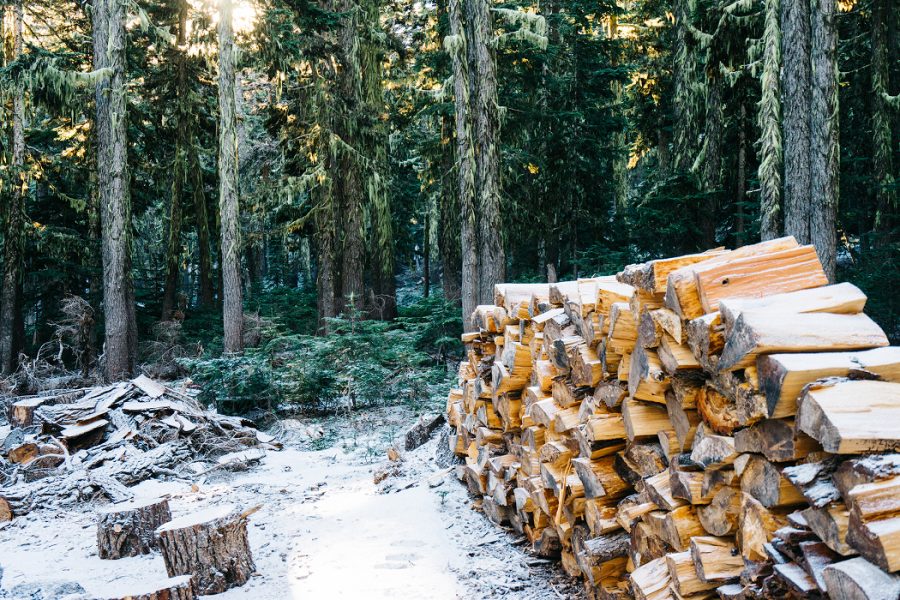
xmin=447 ymin=238 xmax=900 ymax=600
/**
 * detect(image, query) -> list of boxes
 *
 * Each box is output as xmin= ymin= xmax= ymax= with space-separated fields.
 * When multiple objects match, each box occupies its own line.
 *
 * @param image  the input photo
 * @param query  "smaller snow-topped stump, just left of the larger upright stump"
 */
xmin=97 ymin=499 xmax=172 ymax=559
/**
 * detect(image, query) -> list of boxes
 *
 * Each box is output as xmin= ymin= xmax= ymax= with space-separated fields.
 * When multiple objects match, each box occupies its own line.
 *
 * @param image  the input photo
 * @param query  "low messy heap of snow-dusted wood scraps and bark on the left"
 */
xmin=0 ymin=376 xmax=271 ymax=522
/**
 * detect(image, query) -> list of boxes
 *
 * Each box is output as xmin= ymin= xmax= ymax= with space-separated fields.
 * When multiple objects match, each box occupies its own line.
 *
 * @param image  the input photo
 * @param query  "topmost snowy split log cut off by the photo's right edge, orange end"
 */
xmin=757 ymin=346 xmax=900 ymax=418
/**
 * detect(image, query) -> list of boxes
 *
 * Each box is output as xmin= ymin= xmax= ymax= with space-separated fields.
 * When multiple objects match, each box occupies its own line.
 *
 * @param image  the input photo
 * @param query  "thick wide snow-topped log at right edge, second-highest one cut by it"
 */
xmin=797 ymin=378 xmax=900 ymax=454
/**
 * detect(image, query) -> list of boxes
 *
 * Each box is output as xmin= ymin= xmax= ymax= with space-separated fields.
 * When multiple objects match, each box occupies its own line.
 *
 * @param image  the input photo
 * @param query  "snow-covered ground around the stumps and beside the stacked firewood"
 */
xmin=0 ymin=409 xmax=580 ymax=600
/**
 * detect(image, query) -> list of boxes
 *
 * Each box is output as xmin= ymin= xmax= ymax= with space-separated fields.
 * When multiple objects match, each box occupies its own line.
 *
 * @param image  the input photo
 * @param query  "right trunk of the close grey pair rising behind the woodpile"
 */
xmin=809 ymin=0 xmax=841 ymax=282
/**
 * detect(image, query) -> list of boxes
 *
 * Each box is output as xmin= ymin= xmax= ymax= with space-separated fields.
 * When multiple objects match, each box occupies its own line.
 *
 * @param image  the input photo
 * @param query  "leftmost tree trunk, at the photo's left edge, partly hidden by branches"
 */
xmin=0 ymin=0 xmax=28 ymax=375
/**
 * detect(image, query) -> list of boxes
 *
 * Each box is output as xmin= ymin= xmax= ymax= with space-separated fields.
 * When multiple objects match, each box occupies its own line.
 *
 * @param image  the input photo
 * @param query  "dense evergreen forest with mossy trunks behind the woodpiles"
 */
xmin=0 ymin=0 xmax=900 ymax=412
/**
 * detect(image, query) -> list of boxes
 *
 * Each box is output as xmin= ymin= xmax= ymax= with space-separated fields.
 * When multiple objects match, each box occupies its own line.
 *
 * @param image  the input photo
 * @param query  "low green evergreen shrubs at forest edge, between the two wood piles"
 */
xmin=183 ymin=298 xmax=462 ymax=414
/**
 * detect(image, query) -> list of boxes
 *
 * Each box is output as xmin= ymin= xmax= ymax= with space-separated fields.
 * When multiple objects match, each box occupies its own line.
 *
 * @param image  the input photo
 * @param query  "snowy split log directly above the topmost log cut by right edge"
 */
xmin=718 ymin=311 xmax=889 ymax=371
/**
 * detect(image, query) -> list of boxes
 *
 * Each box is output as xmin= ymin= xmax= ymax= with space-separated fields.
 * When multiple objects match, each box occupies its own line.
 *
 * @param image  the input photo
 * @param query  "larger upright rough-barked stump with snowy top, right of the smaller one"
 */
xmin=156 ymin=505 xmax=256 ymax=594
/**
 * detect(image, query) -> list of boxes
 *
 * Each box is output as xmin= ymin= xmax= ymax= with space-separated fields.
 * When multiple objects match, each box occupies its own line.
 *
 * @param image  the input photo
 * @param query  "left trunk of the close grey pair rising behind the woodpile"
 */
xmin=781 ymin=0 xmax=812 ymax=244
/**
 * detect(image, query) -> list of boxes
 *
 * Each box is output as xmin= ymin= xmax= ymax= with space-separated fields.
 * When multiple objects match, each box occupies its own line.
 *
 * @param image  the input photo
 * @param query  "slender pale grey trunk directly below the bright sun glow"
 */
xmin=219 ymin=0 xmax=244 ymax=354
